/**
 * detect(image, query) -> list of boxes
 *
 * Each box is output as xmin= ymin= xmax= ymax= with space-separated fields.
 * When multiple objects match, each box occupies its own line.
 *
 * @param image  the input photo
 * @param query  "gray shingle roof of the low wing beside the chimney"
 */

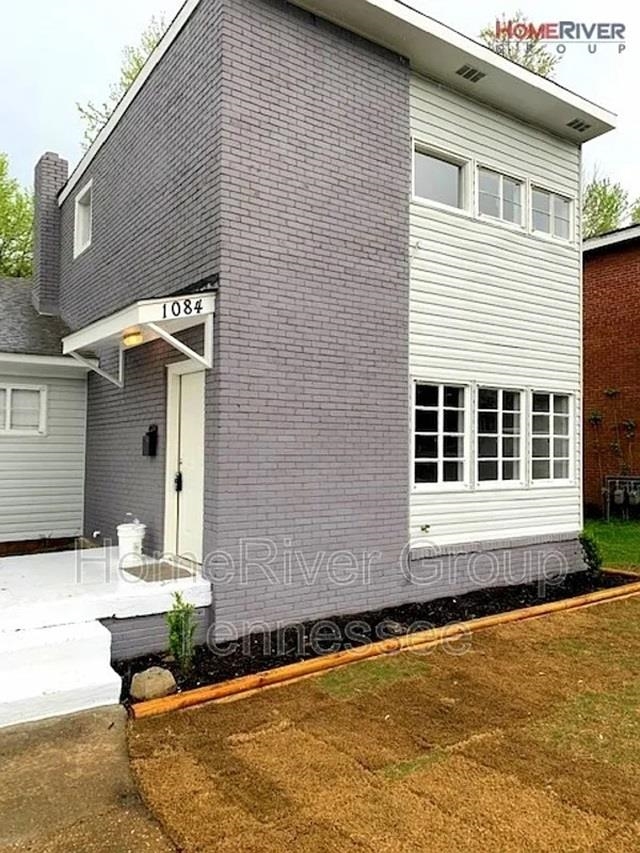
xmin=0 ymin=278 xmax=69 ymax=355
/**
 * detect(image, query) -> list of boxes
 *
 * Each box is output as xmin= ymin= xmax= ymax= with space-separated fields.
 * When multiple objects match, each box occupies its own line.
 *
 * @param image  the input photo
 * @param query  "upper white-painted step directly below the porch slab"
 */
xmin=0 ymin=621 xmax=111 ymax=679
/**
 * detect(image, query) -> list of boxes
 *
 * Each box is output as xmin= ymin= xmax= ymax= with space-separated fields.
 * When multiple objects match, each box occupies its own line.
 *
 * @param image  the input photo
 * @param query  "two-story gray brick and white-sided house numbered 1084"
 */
xmin=28 ymin=0 xmax=614 ymax=650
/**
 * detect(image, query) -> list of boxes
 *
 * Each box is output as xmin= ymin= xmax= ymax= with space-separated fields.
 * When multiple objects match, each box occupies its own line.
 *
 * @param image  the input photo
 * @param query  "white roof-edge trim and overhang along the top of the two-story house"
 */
xmin=58 ymin=0 xmax=616 ymax=205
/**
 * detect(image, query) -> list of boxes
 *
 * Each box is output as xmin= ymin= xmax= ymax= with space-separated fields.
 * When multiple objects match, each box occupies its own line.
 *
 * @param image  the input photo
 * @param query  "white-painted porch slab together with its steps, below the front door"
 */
xmin=0 ymin=548 xmax=211 ymax=727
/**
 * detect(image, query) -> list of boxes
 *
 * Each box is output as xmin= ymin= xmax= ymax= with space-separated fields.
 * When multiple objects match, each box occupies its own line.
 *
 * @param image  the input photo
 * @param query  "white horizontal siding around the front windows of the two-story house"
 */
xmin=410 ymin=77 xmax=582 ymax=544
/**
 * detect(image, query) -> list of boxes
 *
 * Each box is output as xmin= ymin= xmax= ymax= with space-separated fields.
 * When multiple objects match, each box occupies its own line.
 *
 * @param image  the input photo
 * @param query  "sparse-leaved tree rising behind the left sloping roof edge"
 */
xmin=76 ymin=15 xmax=166 ymax=150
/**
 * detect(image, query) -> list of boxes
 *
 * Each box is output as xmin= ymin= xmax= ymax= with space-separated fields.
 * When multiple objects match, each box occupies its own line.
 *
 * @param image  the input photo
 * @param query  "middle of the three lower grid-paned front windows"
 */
xmin=477 ymin=388 xmax=522 ymax=483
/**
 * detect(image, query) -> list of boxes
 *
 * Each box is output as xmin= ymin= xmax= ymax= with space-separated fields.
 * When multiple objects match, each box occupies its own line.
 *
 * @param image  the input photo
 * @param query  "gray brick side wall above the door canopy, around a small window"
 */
xmin=55 ymin=0 xmax=223 ymax=329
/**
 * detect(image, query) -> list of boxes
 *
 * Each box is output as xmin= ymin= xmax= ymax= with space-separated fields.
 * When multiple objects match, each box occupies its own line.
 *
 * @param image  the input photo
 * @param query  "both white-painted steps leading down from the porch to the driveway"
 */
xmin=0 ymin=622 xmax=121 ymax=727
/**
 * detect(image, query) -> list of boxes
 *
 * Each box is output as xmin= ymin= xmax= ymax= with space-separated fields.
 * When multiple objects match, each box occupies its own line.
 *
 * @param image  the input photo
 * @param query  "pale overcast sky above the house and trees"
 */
xmin=0 ymin=0 xmax=640 ymax=198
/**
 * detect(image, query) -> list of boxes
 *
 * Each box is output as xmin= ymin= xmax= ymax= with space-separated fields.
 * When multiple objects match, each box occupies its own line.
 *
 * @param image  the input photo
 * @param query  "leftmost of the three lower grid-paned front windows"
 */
xmin=414 ymin=384 xmax=466 ymax=484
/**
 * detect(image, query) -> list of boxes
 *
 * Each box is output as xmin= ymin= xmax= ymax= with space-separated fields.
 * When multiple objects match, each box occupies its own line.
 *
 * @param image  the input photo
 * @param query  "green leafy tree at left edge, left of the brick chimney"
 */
xmin=0 ymin=152 xmax=33 ymax=278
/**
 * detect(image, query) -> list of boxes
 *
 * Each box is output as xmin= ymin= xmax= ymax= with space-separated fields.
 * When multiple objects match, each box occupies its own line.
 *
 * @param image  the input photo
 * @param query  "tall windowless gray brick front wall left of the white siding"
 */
xmin=205 ymin=0 xmax=411 ymax=627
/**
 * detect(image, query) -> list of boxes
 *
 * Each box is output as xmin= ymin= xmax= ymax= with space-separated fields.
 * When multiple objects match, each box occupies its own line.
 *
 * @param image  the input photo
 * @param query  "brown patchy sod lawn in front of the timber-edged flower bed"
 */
xmin=129 ymin=598 xmax=640 ymax=853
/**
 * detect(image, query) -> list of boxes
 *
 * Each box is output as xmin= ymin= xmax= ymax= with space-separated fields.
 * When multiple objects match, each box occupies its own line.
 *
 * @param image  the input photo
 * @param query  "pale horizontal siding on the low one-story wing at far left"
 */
xmin=0 ymin=373 xmax=87 ymax=542
